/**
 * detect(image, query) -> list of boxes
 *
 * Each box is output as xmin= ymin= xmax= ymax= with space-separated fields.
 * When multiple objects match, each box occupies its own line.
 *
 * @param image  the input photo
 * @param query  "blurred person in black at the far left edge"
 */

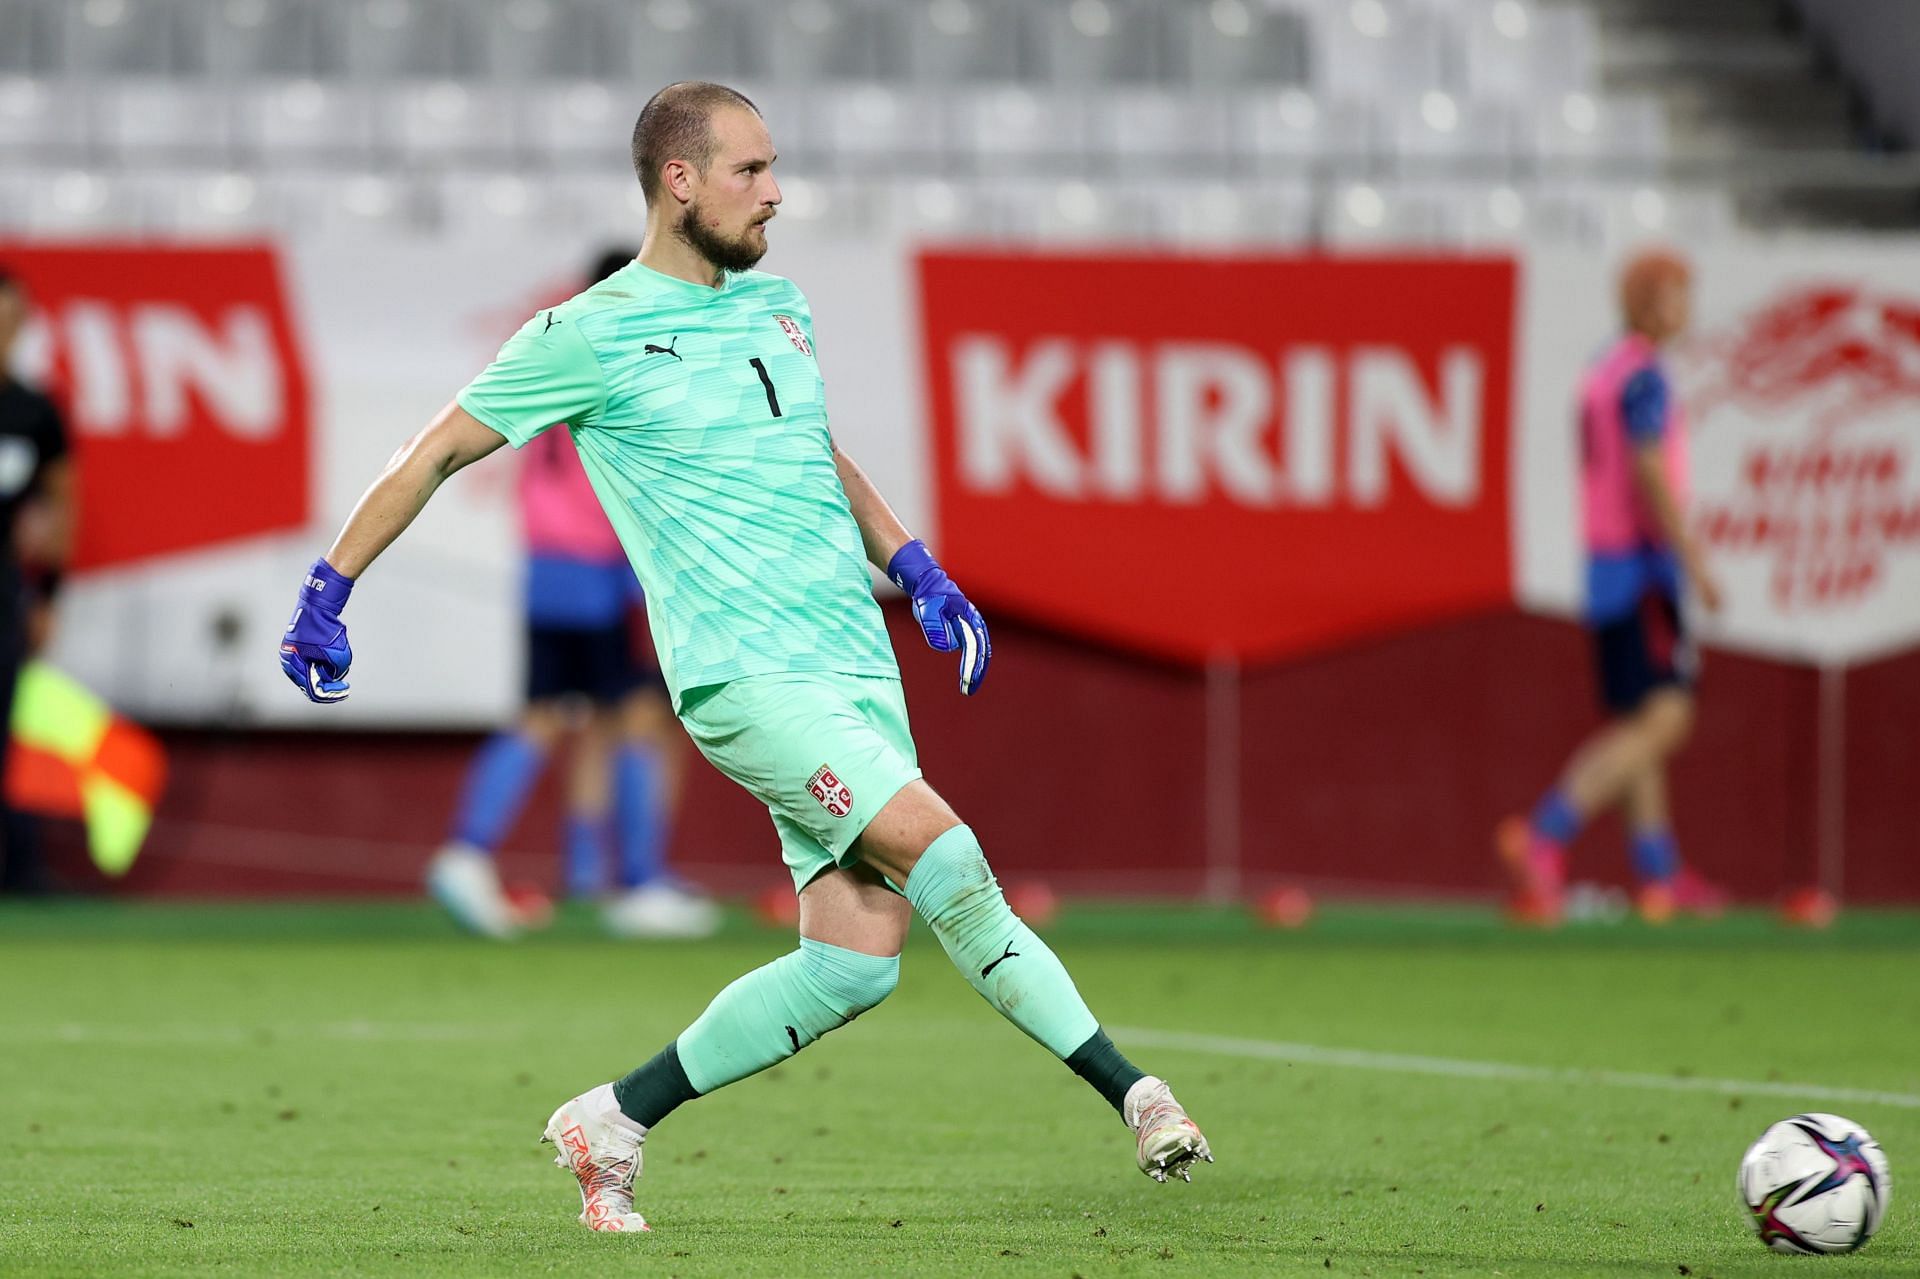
xmin=0 ymin=265 xmax=73 ymax=893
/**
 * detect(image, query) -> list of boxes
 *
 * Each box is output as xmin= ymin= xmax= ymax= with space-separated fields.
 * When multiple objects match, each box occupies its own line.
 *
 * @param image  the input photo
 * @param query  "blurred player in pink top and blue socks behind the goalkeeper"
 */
xmin=426 ymin=252 xmax=720 ymax=937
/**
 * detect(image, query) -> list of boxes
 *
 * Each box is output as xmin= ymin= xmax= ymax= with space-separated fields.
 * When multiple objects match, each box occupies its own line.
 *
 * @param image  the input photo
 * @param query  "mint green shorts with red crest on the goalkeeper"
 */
xmin=680 ymin=674 xmax=920 ymax=891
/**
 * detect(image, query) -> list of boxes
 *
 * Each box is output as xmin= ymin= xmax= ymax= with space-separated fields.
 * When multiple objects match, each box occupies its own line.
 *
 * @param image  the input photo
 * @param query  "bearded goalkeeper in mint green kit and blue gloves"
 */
xmin=280 ymin=83 xmax=1212 ymax=1231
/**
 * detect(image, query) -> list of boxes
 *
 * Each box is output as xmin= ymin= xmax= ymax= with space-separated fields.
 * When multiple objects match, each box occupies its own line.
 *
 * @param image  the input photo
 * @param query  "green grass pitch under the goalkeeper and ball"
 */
xmin=0 ymin=905 xmax=1920 ymax=1279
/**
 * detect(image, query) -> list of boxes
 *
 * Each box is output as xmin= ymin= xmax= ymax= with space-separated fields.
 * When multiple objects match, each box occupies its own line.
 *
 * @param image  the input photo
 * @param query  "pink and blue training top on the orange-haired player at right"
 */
xmin=1580 ymin=334 xmax=1688 ymax=624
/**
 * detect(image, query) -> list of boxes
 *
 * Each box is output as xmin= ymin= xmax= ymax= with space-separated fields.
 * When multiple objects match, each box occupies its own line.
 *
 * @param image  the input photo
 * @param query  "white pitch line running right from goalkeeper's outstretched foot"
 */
xmin=1108 ymin=1026 xmax=1920 ymax=1110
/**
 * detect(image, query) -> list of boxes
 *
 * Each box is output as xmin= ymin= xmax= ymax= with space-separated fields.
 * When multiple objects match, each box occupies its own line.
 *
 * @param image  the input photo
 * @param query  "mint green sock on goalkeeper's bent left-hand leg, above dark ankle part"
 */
xmin=674 ymin=937 xmax=900 ymax=1093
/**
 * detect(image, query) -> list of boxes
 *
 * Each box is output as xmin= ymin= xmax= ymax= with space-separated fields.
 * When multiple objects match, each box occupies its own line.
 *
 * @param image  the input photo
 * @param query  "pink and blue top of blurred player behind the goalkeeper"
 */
xmin=516 ymin=430 xmax=639 ymax=630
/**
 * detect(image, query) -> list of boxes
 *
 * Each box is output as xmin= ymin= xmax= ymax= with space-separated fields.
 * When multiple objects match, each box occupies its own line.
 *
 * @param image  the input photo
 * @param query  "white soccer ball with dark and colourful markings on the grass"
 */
xmin=1740 ymin=1114 xmax=1893 ymax=1252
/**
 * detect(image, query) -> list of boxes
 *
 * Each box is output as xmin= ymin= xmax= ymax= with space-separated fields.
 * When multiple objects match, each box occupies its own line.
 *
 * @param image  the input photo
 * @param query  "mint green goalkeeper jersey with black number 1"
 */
xmin=459 ymin=263 xmax=899 ymax=709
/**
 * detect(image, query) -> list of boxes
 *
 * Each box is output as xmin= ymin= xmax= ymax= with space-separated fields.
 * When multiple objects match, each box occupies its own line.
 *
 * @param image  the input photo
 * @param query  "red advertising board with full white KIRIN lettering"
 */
xmin=918 ymin=252 xmax=1515 ymax=661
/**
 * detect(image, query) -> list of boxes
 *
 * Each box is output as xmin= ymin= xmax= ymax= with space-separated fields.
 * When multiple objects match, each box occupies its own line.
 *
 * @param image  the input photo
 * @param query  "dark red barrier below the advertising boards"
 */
xmin=71 ymin=609 xmax=1920 ymax=901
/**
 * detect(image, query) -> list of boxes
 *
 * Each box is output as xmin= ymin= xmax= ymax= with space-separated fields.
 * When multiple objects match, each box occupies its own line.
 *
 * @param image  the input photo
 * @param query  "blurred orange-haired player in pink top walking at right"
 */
xmin=1498 ymin=250 xmax=1724 ymax=924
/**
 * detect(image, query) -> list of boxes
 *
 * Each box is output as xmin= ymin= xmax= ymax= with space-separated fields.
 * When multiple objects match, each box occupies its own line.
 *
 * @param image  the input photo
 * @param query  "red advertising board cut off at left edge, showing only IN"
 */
xmin=0 ymin=244 xmax=311 ymax=568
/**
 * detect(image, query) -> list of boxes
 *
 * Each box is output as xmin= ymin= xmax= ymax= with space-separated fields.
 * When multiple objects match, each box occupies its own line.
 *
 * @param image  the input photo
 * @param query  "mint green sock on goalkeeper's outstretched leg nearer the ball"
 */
xmin=906 ymin=826 xmax=1100 ymax=1060
